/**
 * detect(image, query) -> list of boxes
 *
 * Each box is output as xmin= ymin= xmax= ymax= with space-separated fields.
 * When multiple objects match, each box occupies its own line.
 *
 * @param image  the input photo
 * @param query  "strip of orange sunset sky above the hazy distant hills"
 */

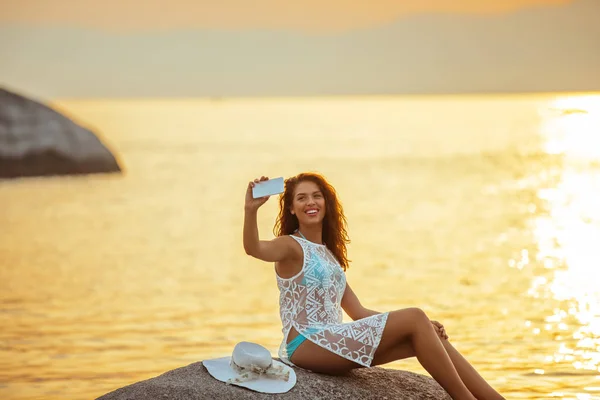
xmin=0 ymin=0 xmax=572 ymax=32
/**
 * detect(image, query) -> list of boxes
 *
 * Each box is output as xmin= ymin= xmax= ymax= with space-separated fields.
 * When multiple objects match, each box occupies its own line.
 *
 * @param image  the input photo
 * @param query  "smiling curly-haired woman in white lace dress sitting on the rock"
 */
xmin=244 ymin=173 xmax=503 ymax=399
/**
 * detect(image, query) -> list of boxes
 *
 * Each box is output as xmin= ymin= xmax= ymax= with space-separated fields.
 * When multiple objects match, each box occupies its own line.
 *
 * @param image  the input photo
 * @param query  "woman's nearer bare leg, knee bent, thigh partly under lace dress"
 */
xmin=291 ymin=308 xmax=475 ymax=400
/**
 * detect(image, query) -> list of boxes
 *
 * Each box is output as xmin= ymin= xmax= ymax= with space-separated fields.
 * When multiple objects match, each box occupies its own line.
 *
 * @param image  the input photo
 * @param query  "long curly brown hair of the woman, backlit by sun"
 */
xmin=273 ymin=172 xmax=350 ymax=271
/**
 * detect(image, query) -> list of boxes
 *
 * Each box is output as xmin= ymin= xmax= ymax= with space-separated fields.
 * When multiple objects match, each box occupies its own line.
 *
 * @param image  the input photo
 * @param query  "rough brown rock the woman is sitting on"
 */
xmin=99 ymin=362 xmax=450 ymax=400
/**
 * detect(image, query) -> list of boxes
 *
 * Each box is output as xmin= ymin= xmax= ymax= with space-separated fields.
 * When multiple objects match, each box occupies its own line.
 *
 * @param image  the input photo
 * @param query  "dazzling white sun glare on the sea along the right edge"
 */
xmin=529 ymin=96 xmax=600 ymax=390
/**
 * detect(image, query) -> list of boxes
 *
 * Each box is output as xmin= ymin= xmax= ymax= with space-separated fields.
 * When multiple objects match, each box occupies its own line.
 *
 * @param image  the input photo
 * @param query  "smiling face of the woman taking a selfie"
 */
xmin=291 ymin=181 xmax=325 ymax=226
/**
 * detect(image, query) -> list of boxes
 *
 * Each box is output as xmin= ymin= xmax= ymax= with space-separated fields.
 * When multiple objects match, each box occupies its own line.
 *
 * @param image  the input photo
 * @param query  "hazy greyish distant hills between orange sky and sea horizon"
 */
xmin=0 ymin=0 xmax=600 ymax=97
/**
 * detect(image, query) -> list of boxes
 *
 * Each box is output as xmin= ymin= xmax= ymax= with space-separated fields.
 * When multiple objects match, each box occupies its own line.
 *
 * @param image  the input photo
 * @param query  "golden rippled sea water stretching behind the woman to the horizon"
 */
xmin=0 ymin=94 xmax=600 ymax=399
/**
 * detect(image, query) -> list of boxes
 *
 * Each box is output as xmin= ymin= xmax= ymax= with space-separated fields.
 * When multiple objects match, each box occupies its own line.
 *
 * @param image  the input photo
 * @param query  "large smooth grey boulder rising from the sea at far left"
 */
xmin=0 ymin=87 xmax=121 ymax=178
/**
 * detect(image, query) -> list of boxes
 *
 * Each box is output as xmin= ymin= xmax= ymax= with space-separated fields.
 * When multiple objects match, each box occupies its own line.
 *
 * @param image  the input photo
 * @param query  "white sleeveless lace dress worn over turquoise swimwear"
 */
xmin=277 ymin=235 xmax=388 ymax=367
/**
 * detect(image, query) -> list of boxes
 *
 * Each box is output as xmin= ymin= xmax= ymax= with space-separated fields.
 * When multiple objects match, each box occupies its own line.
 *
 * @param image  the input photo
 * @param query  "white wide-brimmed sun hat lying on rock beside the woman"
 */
xmin=202 ymin=342 xmax=296 ymax=393
